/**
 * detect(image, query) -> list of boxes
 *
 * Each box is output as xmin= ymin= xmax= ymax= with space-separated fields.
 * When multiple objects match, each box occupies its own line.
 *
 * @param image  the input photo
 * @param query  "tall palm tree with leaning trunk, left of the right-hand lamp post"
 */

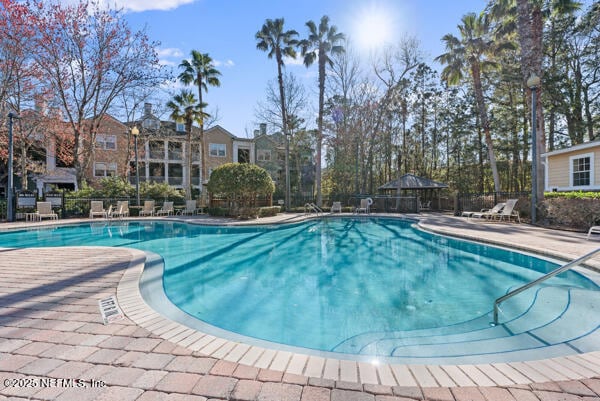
xmin=435 ymin=13 xmax=512 ymax=192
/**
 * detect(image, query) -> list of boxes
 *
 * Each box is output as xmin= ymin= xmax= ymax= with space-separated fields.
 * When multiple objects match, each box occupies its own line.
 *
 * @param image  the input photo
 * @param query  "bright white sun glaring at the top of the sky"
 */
xmin=352 ymin=5 xmax=393 ymax=50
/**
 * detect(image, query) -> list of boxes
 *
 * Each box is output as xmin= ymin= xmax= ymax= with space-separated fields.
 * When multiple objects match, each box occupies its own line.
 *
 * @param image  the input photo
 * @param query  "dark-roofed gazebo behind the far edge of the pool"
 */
xmin=377 ymin=174 xmax=448 ymax=211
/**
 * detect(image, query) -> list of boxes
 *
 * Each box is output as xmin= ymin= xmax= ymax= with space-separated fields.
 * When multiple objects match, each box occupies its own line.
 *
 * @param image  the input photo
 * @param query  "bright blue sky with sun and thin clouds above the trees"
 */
xmin=113 ymin=0 xmax=486 ymax=137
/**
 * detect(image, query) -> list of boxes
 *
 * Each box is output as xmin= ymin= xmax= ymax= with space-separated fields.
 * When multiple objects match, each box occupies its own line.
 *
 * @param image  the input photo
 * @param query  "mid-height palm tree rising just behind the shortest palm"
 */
xmin=179 ymin=50 xmax=221 ymax=190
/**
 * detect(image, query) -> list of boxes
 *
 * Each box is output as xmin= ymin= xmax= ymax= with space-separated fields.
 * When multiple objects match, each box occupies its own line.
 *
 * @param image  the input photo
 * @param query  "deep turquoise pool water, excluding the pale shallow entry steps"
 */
xmin=0 ymin=218 xmax=596 ymax=351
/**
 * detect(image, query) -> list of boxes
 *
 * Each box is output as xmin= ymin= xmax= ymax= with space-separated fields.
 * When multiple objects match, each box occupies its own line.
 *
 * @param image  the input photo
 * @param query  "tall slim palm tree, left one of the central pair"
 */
xmin=255 ymin=18 xmax=298 ymax=210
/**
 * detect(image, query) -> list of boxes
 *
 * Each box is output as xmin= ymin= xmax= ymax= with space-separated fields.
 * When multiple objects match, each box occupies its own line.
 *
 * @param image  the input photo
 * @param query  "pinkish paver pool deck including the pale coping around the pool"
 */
xmin=0 ymin=214 xmax=600 ymax=401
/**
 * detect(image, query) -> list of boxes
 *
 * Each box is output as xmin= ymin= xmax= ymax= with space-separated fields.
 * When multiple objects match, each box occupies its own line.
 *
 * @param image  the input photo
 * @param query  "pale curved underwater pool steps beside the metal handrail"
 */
xmin=334 ymin=287 xmax=600 ymax=358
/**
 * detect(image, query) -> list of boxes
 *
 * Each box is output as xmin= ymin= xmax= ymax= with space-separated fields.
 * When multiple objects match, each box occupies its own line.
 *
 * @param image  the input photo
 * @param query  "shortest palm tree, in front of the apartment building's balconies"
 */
xmin=167 ymin=89 xmax=208 ymax=199
